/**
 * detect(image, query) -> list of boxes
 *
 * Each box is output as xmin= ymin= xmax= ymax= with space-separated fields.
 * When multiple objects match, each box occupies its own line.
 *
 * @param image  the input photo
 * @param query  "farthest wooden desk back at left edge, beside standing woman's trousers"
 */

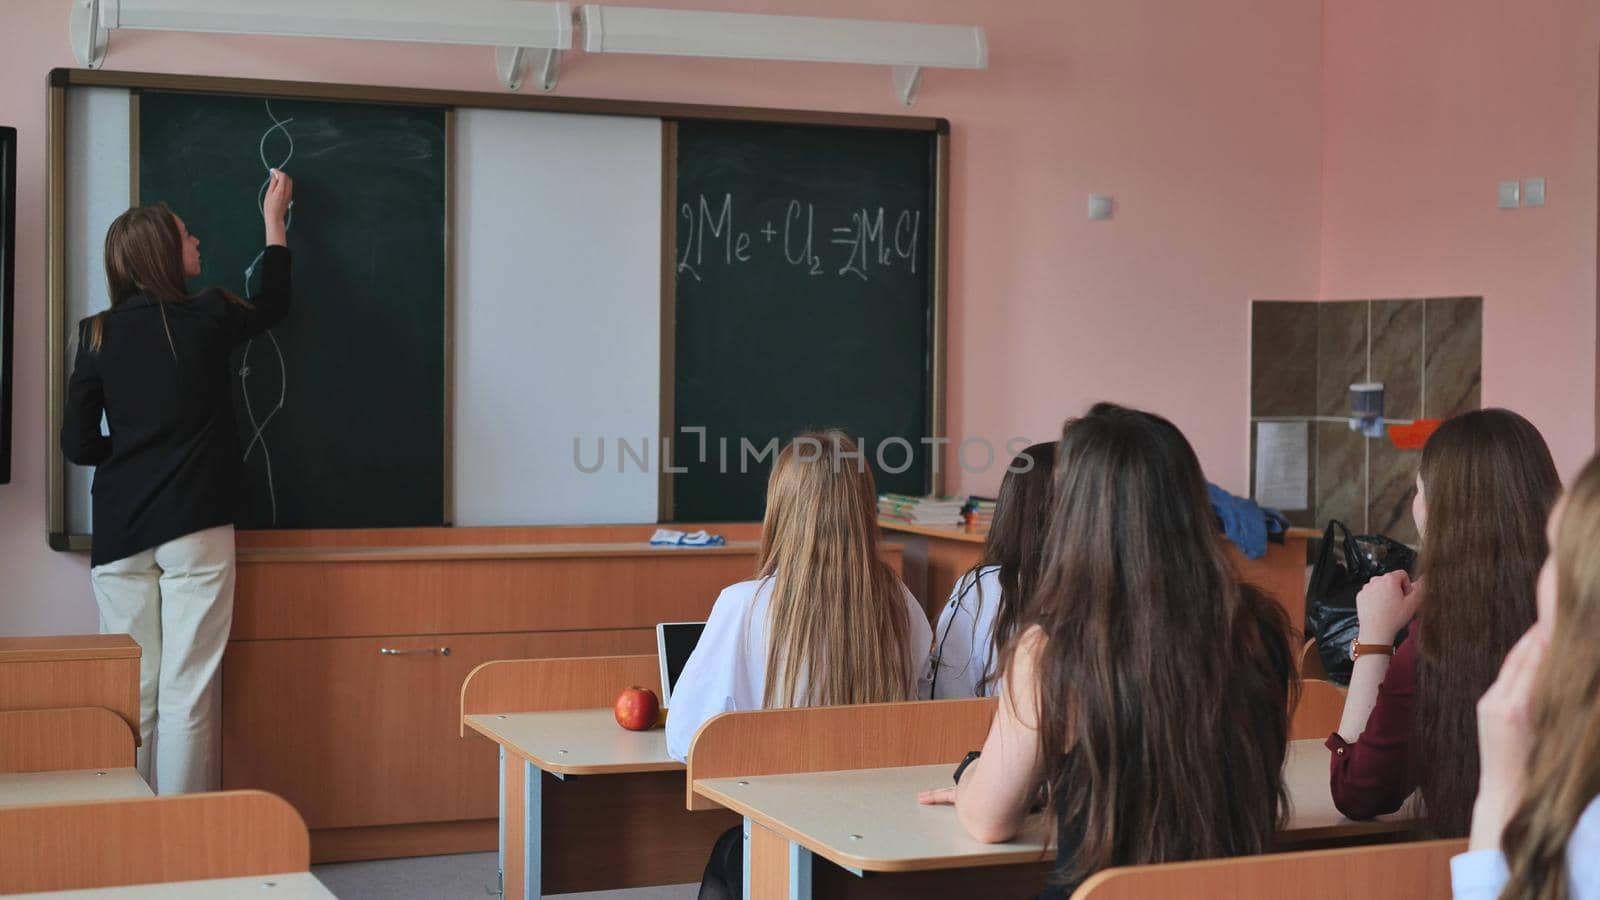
xmin=0 ymin=634 xmax=139 ymax=741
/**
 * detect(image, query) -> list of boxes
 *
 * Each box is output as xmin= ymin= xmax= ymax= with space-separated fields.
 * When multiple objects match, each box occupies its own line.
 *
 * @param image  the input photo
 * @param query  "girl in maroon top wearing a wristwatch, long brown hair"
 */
xmin=1328 ymin=410 xmax=1562 ymax=838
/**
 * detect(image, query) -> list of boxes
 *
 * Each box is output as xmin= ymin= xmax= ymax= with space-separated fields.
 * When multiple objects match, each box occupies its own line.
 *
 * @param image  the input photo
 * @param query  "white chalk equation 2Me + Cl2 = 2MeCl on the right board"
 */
xmin=677 ymin=194 xmax=923 ymax=282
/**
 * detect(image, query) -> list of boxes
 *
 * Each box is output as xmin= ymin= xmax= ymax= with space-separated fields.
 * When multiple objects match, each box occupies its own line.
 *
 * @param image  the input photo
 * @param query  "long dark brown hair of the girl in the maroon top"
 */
xmin=1411 ymin=410 xmax=1562 ymax=838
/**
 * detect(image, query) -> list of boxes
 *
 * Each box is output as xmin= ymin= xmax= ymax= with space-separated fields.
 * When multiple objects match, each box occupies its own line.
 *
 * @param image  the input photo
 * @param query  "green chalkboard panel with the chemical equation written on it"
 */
xmin=672 ymin=120 xmax=936 ymax=520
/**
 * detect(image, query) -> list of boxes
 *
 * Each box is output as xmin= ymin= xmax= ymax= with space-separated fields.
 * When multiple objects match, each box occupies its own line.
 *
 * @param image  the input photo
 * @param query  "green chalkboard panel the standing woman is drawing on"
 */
xmin=136 ymin=91 xmax=446 ymax=528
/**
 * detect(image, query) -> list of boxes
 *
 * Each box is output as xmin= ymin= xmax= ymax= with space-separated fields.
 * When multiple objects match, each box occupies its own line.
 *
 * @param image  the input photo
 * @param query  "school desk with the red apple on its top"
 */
xmin=462 ymin=709 xmax=738 ymax=900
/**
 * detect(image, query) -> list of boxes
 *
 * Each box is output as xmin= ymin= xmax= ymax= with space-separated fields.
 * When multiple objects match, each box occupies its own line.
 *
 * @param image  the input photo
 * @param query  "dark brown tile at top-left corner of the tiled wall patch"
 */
xmin=1250 ymin=299 xmax=1318 ymax=416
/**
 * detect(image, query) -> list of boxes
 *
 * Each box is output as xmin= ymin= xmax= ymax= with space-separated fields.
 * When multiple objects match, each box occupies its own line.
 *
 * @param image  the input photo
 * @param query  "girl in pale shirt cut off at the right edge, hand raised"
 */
xmin=1450 ymin=456 xmax=1600 ymax=900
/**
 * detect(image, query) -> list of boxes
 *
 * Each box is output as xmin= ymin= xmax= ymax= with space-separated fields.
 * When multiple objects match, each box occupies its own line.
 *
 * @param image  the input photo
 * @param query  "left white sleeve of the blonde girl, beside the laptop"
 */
xmin=667 ymin=585 xmax=746 ymax=762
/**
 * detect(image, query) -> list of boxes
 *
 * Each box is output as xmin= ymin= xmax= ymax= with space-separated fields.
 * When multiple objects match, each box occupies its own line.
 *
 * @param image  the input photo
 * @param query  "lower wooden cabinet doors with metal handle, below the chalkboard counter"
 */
xmin=222 ymin=629 xmax=656 ymax=830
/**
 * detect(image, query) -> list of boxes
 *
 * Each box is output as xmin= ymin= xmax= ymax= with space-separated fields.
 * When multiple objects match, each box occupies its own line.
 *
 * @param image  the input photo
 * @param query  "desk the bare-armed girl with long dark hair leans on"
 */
xmin=694 ymin=741 xmax=1408 ymax=900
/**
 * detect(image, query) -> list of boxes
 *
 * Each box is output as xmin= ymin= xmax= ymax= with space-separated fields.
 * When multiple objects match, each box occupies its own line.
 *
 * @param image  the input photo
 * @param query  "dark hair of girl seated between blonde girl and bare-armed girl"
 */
xmin=958 ymin=440 xmax=1056 ymax=695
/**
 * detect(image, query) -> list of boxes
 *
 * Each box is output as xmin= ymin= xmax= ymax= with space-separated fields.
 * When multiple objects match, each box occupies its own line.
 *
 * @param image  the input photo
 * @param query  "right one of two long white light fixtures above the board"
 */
xmin=582 ymin=3 xmax=989 ymax=106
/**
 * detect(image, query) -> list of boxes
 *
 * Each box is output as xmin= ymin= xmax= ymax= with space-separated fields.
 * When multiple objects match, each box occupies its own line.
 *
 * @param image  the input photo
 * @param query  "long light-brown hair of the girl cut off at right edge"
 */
xmin=1501 ymin=456 xmax=1600 ymax=900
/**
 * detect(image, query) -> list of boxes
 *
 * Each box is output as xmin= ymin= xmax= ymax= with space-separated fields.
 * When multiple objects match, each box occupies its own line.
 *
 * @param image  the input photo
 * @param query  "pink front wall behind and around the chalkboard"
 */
xmin=0 ymin=0 xmax=1324 ymax=634
